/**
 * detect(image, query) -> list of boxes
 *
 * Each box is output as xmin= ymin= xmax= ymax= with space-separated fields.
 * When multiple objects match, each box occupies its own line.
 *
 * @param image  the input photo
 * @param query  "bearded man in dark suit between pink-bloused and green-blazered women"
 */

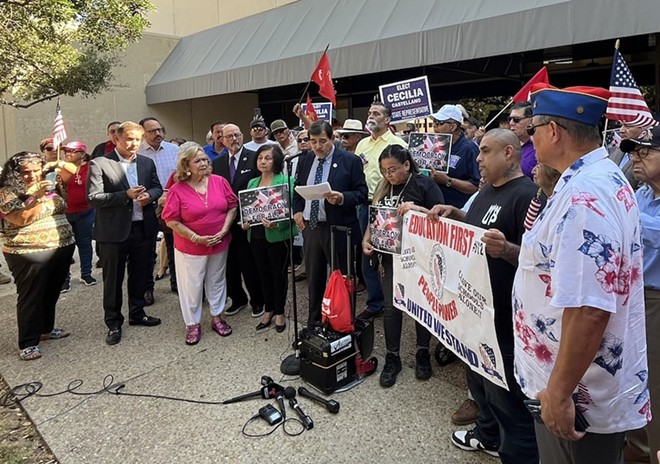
xmin=213 ymin=124 xmax=264 ymax=317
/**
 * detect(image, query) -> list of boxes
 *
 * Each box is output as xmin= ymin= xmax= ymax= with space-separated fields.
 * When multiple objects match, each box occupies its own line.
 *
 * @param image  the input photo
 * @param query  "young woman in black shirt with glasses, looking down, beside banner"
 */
xmin=362 ymin=145 xmax=444 ymax=388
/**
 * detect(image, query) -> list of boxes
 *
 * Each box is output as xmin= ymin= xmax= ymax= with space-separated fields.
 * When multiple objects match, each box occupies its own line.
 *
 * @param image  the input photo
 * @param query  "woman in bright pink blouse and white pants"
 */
xmin=162 ymin=144 xmax=238 ymax=345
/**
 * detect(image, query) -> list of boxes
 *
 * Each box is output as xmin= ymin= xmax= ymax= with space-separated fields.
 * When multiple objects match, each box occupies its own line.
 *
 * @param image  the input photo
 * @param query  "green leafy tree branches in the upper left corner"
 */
xmin=0 ymin=0 xmax=155 ymax=108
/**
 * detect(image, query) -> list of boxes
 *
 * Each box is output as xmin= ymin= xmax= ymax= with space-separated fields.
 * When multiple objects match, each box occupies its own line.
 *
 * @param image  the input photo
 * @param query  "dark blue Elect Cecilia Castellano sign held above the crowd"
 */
xmin=378 ymin=76 xmax=433 ymax=124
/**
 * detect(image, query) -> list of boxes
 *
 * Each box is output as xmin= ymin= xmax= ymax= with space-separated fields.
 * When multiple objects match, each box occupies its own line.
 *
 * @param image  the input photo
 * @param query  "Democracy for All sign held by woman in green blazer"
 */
xmin=238 ymin=184 xmax=289 ymax=227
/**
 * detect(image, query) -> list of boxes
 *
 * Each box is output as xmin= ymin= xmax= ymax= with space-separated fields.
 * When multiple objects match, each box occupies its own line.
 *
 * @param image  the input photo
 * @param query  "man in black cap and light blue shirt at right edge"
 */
xmin=621 ymin=127 xmax=660 ymax=464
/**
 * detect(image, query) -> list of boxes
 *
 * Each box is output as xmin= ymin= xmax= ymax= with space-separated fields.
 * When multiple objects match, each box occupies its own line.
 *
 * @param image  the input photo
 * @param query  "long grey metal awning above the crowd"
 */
xmin=146 ymin=0 xmax=660 ymax=104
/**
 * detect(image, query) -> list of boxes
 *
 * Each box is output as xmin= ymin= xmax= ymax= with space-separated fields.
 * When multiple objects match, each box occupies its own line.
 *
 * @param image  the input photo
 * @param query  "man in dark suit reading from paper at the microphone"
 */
xmin=293 ymin=121 xmax=368 ymax=324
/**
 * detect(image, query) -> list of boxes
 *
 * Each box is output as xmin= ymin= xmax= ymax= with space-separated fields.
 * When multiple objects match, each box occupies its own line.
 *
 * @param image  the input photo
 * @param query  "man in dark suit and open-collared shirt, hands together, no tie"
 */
xmin=87 ymin=122 xmax=163 ymax=345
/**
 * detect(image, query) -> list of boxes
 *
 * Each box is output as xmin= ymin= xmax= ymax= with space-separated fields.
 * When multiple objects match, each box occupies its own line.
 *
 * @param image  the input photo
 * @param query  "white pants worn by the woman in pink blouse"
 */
xmin=174 ymin=250 xmax=227 ymax=326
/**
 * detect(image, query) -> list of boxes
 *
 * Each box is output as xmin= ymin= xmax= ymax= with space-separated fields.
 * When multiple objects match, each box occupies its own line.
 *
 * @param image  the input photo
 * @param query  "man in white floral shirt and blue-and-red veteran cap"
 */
xmin=512 ymin=84 xmax=650 ymax=464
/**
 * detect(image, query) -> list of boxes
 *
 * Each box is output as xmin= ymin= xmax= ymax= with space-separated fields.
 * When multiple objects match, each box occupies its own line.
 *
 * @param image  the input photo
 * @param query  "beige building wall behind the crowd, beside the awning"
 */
xmin=0 ymin=0 xmax=295 ymax=162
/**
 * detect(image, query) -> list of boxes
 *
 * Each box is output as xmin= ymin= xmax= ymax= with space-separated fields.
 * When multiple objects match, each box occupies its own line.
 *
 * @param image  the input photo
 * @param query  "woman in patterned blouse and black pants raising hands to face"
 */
xmin=0 ymin=151 xmax=76 ymax=361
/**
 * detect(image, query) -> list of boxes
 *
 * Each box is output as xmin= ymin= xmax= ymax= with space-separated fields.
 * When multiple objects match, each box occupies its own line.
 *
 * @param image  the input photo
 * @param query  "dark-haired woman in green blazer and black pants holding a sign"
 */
xmin=243 ymin=145 xmax=298 ymax=332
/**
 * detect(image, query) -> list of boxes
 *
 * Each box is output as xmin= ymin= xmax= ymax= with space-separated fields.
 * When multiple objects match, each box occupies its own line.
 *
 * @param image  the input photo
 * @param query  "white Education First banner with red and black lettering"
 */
xmin=393 ymin=211 xmax=508 ymax=390
